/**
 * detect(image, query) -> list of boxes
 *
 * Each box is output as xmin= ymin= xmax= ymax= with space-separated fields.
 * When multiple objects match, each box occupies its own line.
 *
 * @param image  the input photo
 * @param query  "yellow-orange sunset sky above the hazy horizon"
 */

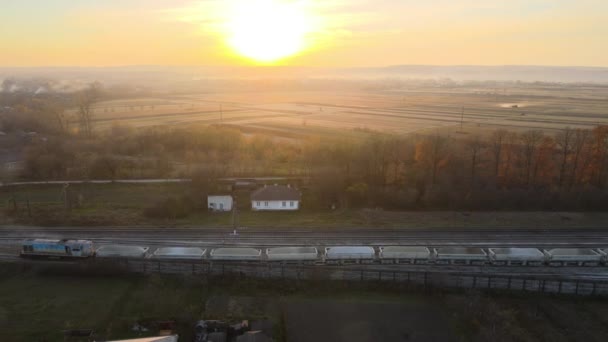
xmin=0 ymin=0 xmax=608 ymax=67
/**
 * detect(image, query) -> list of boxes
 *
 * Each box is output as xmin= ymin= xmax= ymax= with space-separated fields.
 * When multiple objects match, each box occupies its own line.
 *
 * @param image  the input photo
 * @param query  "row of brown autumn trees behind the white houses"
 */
xmin=16 ymin=121 xmax=608 ymax=207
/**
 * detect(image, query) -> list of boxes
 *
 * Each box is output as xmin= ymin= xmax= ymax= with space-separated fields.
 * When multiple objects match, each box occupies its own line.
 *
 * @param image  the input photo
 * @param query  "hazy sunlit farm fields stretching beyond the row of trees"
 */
xmin=79 ymin=84 xmax=608 ymax=136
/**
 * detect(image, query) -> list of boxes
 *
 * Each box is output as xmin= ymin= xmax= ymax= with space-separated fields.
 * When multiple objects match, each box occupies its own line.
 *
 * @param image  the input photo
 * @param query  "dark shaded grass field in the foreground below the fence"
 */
xmin=0 ymin=264 xmax=608 ymax=342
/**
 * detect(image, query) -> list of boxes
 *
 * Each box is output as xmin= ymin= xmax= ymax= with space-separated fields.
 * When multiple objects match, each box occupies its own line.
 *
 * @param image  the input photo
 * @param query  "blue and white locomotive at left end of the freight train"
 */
xmin=21 ymin=239 xmax=95 ymax=258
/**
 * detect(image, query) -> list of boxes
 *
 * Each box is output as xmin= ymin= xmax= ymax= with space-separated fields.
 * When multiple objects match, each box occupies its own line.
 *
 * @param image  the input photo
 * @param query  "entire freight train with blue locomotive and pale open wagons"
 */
xmin=21 ymin=239 xmax=608 ymax=266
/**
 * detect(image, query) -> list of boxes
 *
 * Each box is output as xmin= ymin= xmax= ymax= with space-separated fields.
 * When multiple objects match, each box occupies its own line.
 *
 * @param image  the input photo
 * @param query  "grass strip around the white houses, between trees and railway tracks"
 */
xmin=0 ymin=183 xmax=608 ymax=228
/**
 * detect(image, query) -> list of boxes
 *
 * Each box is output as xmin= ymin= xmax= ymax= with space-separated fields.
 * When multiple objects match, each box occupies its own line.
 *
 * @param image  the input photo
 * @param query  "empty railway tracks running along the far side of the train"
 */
xmin=0 ymin=226 xmax=608 ymax=248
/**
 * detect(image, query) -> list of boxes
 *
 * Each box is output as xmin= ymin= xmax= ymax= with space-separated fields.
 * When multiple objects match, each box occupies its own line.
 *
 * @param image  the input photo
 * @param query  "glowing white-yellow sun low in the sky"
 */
xmin=227 ymin=0 xmax=312 ymax=63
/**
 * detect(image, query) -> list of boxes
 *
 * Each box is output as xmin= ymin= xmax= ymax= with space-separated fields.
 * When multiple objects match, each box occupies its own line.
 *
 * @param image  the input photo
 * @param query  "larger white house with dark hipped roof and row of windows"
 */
xmin=251 ymin=184 xmax=302 ymax=210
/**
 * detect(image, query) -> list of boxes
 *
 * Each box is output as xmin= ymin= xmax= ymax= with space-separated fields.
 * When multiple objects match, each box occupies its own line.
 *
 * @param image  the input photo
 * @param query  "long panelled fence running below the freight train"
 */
xmin=86 ymin=259 xmax=608 ymax=296
